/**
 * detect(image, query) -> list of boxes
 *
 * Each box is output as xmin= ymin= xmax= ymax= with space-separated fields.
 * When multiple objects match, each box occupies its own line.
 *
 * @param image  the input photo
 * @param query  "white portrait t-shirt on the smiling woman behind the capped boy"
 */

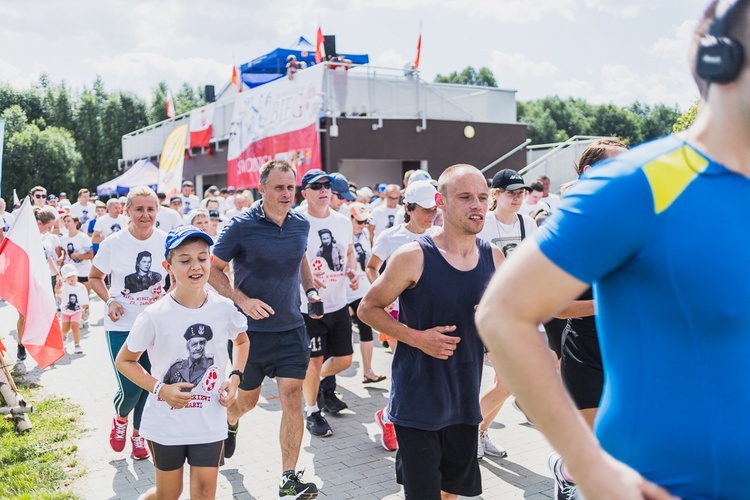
xmin=93 ymin=228 xmax=167 ymax=332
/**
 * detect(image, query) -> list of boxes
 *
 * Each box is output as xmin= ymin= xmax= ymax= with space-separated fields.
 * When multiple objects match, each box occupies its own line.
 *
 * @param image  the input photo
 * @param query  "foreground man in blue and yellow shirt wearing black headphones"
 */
xmin=477 ymin=0 xmax=750 ymax=499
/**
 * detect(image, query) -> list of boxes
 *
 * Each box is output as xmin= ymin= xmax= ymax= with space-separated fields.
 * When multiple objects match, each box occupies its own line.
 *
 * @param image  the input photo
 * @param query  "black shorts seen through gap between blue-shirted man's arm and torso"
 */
xmin=560 ymin=326 xmax=604 ymax=410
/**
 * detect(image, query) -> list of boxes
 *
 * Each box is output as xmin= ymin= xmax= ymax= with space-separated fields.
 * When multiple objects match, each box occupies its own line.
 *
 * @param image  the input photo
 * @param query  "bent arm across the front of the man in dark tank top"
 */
xmin=357 ymin=243 xmax=461 ymax=359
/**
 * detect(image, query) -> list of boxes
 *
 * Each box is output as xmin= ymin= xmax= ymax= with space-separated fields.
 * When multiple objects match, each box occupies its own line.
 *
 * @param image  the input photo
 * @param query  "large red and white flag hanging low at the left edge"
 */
xmin=0 ymin=197 xmax=65 ymax=369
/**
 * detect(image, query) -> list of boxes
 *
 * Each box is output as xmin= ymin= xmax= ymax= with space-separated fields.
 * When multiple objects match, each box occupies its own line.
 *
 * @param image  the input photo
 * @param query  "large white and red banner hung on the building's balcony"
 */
xmin=227 ymin=64 xmax=324 ymax=188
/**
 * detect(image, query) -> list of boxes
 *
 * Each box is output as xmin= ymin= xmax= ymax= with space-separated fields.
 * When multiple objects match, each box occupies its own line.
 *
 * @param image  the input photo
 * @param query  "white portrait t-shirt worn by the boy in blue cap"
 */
xmin=126 ymin=292 xmax=247 ymax=446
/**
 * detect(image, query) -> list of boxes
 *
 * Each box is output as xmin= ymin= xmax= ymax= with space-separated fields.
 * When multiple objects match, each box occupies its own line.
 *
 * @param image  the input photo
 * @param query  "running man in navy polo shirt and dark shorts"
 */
xmin=209 ymin=160 xmax=320 ymax=498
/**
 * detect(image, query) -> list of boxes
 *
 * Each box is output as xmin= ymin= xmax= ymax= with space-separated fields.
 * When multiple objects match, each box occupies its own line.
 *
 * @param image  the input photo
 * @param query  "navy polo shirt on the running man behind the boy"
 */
xmin=214 ymin=200 xmax=310 ymax=332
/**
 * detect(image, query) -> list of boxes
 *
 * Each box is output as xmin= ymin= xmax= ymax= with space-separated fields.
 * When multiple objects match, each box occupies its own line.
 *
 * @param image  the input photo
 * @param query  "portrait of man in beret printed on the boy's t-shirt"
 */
xmin=164 ymin=323 xmax=218 ymax=393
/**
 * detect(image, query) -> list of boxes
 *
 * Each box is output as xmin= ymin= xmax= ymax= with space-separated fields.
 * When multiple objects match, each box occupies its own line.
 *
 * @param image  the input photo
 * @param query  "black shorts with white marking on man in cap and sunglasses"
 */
xmin=302 ymin=306 xmax=354 ymax=358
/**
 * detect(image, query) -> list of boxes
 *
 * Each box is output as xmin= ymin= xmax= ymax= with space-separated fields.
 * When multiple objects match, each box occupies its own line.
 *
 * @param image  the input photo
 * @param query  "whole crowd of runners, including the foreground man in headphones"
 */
xmin=5 ymin=1 xmax=750 ymax=499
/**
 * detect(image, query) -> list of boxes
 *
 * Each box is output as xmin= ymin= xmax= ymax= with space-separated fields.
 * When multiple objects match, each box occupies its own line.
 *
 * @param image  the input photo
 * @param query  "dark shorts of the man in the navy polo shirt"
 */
xmin=239 ymin=326 xmax=310 ymax=391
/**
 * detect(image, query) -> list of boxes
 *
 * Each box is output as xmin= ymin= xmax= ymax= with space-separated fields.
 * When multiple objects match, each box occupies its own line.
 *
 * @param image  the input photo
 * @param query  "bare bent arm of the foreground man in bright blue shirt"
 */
xmin=477 ymin=242 xmax=671 ymax=499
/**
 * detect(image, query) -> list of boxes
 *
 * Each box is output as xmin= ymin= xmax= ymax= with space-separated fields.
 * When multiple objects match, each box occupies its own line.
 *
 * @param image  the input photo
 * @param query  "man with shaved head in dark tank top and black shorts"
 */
xmin=358 ymin=165 xmax=504 ymax=500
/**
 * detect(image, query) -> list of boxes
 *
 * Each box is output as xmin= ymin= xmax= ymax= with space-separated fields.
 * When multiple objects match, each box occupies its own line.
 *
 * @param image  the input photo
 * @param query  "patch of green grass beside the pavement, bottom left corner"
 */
xmin=0 ymin=378 xmax=83 ymax=500
